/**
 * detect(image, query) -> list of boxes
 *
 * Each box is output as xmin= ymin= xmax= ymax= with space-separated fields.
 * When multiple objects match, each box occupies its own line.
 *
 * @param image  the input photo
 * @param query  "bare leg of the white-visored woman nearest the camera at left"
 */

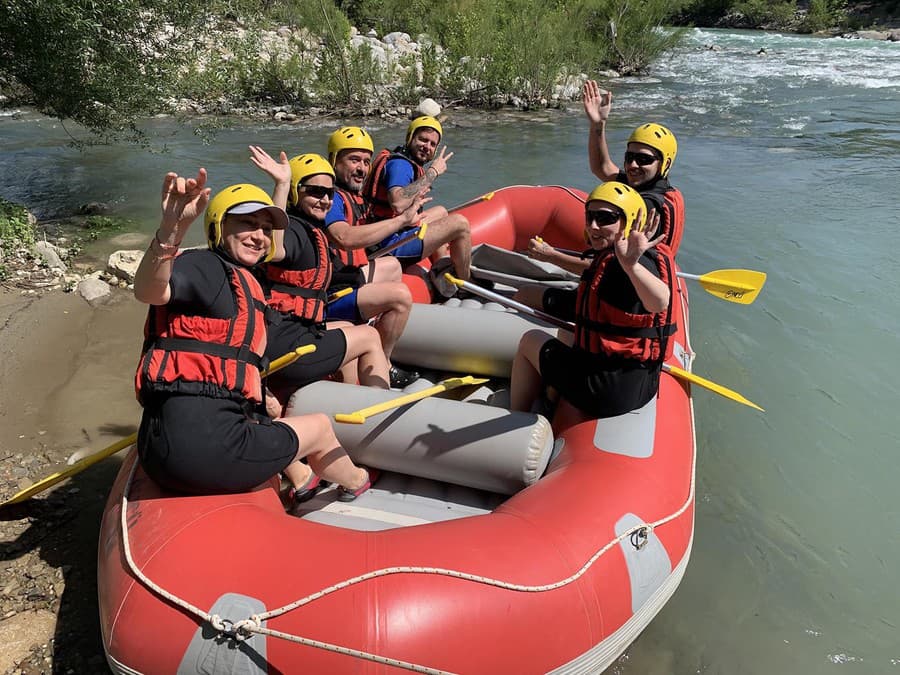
xmin=278 ymin=413 xmax=369 ymax=490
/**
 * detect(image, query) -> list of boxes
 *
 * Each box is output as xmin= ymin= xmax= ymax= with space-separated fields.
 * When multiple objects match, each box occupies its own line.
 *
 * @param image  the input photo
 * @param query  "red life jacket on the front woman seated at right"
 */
xmin=575 ymin=244 xmax=676 ymax=363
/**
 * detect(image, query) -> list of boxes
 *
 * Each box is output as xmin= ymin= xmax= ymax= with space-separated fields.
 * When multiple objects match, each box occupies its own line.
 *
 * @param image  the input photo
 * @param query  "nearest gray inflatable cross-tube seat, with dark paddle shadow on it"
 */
xmin=286 ymin=381 xmax=553 ymax=495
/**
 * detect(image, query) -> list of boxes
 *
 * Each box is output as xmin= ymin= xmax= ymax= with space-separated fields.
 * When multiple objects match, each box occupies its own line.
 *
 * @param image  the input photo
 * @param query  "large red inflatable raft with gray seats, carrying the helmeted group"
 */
xmin=98 ymin=187 xmax=695 ymax=675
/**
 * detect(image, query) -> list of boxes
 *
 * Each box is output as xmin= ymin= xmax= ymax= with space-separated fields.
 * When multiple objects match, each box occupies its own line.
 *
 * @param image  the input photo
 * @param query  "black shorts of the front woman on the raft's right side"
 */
xmin=540 ymin=339 xmax=660 ymax=418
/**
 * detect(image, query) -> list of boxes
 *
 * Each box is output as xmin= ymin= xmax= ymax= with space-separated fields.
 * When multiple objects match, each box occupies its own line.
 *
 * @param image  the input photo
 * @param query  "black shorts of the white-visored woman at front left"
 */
xmin=138 ymin=395 xmax=299 ymax=494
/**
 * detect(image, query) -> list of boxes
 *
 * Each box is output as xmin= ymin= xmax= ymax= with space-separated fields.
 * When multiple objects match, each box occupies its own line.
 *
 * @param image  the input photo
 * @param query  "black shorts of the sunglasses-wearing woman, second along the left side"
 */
xmin=266 ymin=319 xmax=347 ymax=401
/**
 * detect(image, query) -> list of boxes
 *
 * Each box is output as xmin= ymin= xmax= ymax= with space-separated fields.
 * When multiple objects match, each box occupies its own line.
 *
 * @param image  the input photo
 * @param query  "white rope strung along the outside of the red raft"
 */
xmin=120 ymin=336 xmax=697 ymax=675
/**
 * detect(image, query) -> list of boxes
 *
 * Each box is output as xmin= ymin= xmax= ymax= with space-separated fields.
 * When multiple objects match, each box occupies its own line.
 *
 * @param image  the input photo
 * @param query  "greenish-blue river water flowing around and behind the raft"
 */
xmin=0 ymin=29 xmax=900 ymax=675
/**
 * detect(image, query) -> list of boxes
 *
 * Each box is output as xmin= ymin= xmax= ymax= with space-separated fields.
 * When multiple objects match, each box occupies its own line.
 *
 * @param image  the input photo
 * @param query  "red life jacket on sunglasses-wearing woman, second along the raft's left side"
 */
xmin=266 ymin=214 xmax=332 ymax=323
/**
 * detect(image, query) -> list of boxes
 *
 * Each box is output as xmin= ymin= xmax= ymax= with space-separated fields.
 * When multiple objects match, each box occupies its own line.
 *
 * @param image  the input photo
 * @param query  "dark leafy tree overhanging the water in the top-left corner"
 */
xmin=0 ymin=0 xmax=229 ymax=137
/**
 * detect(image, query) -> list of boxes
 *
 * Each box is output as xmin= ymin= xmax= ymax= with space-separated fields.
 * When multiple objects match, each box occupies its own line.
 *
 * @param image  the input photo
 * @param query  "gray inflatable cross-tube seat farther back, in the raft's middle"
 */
xmin=391 ymin=298 xmax=557 ymax=377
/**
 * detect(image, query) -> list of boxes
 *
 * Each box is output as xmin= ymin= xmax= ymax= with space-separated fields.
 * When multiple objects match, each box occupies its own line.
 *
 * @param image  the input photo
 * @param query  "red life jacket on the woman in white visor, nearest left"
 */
xmin=134 ymin=254 xmax=266 ymax=405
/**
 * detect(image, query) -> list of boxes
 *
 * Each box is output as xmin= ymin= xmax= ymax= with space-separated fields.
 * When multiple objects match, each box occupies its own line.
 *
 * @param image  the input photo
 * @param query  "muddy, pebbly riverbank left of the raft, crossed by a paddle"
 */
xmin=0 ymin=290 xmax=145 ymax=674
